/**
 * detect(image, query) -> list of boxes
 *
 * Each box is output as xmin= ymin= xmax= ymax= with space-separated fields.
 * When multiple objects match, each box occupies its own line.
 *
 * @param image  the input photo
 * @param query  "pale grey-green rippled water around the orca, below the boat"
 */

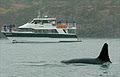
xmin=0 ymin=39 xmax=120 ymax=77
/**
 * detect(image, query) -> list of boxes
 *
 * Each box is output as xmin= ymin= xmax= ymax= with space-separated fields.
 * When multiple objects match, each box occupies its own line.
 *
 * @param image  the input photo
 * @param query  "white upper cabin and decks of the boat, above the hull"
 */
xmin=1 ymin=16 xmax=76 ymax=34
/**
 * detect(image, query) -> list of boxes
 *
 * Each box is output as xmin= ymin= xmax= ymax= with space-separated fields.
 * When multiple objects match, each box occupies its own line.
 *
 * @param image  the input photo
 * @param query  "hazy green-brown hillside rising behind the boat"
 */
xmin=0 ymin=0 xmax=120 ymax=37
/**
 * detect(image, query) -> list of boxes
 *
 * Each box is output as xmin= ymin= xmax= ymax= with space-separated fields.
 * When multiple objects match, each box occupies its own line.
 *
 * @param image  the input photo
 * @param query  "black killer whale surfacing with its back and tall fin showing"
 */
xmin=61 ymin=43 xmax=112 ymax=64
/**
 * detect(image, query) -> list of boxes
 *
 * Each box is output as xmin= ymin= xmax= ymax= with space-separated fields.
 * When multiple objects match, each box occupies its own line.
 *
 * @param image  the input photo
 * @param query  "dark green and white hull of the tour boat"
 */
xmin=3 ymin=33 xmax=78 ymax=43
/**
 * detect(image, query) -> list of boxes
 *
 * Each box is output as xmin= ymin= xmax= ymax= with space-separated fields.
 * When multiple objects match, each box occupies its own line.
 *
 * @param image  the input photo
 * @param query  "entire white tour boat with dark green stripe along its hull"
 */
xmin=2 ymin=16 xmax=79 ymax=43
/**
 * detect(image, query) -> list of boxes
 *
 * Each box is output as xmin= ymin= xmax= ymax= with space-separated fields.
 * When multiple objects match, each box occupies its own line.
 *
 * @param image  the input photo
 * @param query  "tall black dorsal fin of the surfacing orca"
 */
xmin=97 ymin=43 xmax=111 ymax=62
